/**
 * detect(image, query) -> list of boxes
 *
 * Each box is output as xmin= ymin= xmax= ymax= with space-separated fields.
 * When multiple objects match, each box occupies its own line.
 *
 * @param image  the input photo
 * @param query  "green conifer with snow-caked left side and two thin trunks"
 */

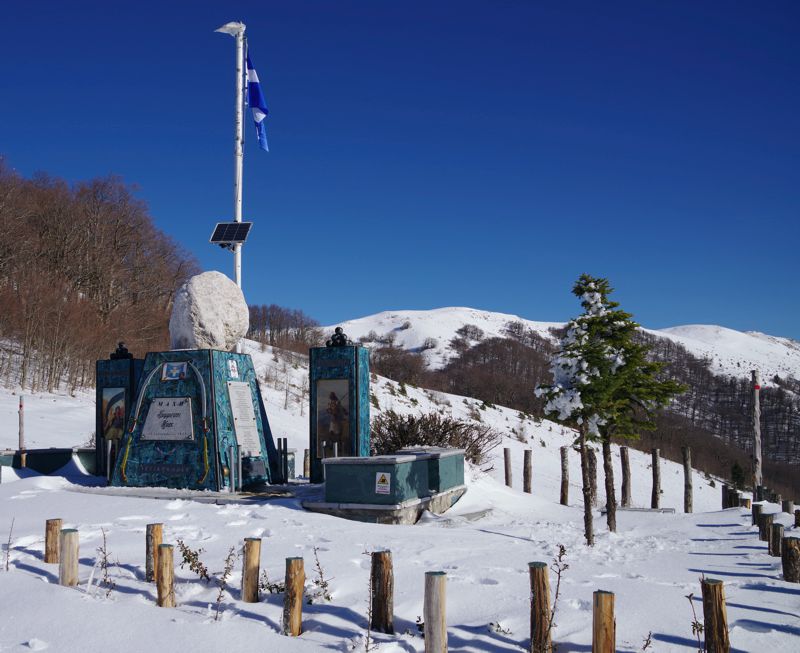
xmin=536 ymin=274 xmax=684 ymax=546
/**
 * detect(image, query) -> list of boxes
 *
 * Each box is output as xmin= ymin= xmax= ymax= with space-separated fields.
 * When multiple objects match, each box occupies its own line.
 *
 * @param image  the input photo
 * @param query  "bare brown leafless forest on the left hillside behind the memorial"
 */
xmin=0 ymin=160 xmax=198 ymax=391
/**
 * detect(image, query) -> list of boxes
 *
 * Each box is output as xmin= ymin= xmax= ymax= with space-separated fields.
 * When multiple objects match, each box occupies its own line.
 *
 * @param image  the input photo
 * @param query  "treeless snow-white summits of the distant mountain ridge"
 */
xmin=325 ymin=306 xmax=800 ymax=385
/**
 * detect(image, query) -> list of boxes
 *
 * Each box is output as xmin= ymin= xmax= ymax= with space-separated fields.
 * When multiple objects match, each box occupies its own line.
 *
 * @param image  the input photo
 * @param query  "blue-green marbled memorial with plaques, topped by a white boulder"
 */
xmin=111 ymin=272 xmax=282 ymax=491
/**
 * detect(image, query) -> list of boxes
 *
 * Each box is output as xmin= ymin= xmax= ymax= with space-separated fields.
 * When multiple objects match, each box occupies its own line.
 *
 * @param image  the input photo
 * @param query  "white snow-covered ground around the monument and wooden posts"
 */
xmin=0 ymin=338 xmax=800 ymax=653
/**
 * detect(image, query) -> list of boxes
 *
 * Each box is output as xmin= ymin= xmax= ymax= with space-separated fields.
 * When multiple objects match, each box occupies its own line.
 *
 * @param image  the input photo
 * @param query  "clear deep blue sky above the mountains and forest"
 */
xmin=0 ymin=0 xmax=800 ymax=339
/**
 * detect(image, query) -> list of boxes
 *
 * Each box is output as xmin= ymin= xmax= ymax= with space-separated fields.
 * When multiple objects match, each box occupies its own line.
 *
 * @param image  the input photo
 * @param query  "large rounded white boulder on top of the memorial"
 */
xmin=169 ymin=272 xmax=250 ymax=351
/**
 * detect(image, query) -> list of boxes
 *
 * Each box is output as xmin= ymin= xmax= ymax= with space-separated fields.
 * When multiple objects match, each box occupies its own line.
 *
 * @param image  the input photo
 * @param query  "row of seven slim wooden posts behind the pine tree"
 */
xmin=503 ymin=447 xmax=692 ymax=512
